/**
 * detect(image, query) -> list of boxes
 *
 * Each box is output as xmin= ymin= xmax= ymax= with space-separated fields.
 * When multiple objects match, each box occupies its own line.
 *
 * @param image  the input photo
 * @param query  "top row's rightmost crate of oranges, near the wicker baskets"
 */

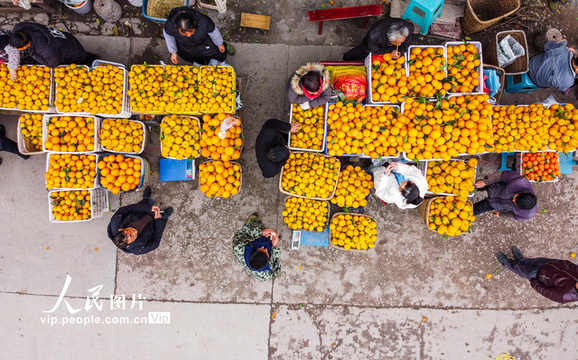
xmin=445 ymin=41 xmax=484 ymax=95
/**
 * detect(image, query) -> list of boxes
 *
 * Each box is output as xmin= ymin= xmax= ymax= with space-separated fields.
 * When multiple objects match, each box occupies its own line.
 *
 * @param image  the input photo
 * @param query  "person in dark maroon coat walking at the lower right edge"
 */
xmin=497 ymin=246 xmax=578 ymax=304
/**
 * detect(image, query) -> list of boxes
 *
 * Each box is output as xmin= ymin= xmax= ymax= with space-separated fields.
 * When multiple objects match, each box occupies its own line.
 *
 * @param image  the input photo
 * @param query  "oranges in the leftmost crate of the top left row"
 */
xmin=0 ymin=64 xmax=50 ymax=111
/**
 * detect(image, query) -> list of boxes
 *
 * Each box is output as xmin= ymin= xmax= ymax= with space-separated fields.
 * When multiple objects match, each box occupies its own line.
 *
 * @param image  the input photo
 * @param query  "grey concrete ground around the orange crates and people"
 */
xmin=0 ymin=32 xmax=578 ymax=360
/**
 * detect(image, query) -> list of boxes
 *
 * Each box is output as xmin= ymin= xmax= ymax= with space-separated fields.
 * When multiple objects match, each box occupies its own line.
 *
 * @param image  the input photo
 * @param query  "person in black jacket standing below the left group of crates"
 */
xmin=107 ymin=186 xmax=173 ymax=255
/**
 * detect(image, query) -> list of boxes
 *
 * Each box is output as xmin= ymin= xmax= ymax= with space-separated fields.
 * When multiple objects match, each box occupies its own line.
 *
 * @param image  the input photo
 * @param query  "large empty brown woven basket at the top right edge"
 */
xmin=462 ymin=0 xmax=520 ymax=35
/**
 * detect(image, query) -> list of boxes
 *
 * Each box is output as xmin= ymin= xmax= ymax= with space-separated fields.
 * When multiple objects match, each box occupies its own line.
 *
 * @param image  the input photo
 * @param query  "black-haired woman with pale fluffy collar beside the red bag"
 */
xmin=287 ymin=63 xmax=331 ymax=110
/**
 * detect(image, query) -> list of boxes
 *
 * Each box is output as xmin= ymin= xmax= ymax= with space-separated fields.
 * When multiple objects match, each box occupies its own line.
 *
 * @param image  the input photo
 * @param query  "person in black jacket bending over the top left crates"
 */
xmin=10 ymin=22 xmax=96 ymax=68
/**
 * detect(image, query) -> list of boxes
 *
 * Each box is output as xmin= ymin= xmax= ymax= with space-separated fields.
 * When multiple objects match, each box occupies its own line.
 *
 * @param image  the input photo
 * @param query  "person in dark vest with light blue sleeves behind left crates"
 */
xmin=163 ymin=6 xmax=235 ymax=65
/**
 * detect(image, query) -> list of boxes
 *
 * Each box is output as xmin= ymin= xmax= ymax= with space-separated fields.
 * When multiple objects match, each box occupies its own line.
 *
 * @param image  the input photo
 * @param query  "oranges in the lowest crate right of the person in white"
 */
xmin=428 ymin=195 xmax=476 ymax=236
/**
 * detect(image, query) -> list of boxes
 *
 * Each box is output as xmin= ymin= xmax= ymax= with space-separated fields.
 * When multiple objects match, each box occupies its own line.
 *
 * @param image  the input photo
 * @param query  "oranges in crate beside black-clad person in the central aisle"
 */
xmin=289 ymin=104 xmax=325 ymax=150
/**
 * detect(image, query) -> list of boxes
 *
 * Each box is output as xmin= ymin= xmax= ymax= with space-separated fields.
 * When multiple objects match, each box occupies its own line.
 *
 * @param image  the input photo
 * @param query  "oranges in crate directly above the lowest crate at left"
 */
xmin=44 ymin=154 xmax=96 ymax=190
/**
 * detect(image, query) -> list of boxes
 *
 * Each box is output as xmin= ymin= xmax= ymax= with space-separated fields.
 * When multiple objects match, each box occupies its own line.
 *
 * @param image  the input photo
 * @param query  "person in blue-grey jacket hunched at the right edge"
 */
xmin=528 ymin=40 xmax=578 ymax=92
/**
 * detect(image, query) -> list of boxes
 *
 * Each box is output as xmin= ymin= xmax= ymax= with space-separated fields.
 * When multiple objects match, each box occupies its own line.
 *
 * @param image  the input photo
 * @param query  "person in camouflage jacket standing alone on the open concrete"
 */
xmin=233 ymin=213 xmax=281 ymax=281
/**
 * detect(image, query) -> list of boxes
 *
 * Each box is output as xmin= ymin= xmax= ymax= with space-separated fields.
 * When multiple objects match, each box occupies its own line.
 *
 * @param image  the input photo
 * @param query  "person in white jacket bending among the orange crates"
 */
xmin=373 ymin=162 xmax=428 ymax=209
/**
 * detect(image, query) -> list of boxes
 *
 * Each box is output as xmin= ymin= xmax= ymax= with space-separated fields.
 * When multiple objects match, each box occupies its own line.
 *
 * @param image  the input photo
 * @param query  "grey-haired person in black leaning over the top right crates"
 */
xmin=343 ymin=18 xmax=414 ymax=61
